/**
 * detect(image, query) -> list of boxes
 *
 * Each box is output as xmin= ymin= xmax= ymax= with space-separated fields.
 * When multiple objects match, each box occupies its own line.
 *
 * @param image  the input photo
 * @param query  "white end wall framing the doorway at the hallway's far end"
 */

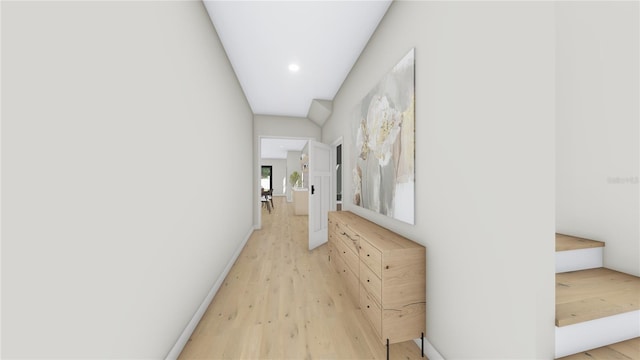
xmin=253 ymin=115 xmax=322 ymax=227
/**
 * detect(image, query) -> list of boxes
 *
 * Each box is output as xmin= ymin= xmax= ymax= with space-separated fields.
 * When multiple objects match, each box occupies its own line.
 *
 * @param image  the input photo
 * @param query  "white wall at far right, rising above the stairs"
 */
xmin=556 ymin=1 xmax=640 ymax=276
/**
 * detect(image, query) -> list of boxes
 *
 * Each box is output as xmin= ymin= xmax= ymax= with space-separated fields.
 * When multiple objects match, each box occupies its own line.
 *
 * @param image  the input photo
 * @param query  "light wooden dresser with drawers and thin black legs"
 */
xmin=329 ymin=211 xmax=426 ymax=344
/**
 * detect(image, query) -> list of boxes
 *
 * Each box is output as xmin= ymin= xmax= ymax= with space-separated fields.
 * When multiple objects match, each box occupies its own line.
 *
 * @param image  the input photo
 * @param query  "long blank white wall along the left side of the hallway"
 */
xmin=2 ymin=1 xmax=253 ymax=359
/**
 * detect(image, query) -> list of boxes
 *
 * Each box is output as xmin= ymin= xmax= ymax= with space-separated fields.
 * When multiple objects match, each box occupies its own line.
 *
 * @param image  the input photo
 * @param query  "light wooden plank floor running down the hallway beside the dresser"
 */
xmin=180 ymin=197 xmax=426 ymax=359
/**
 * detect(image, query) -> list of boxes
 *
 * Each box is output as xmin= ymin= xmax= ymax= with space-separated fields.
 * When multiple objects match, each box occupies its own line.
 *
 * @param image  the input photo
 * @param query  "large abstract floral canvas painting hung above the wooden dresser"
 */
xmin=352 ymin=49 xmax=415 ymax=224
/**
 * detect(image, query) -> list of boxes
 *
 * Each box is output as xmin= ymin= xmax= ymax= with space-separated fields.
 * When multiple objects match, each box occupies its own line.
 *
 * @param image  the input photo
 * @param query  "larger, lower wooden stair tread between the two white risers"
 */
xmin=556 ymin=268 xmax=640 ymax=326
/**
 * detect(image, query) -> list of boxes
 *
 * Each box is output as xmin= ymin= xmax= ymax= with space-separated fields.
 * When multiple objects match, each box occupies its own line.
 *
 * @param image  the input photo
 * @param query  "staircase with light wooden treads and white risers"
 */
xmin=556 ymin=234 xmax=640 ymax=359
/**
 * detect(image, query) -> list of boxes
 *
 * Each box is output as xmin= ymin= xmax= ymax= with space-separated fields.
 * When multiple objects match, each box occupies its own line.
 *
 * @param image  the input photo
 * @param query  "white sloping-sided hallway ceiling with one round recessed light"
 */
xmin=204 ymin=0 xmax=391 ymax=117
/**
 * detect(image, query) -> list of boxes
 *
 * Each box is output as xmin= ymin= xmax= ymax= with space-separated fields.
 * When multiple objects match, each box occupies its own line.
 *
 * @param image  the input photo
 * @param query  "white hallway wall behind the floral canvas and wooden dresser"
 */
xmin=322 ymin=1 xmax=555 ymax=359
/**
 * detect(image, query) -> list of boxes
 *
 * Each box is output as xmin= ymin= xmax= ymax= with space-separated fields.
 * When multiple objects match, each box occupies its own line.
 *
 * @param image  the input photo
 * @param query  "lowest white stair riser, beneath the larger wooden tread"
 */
xmin=556 ymin=310 xmax=640 ymax=358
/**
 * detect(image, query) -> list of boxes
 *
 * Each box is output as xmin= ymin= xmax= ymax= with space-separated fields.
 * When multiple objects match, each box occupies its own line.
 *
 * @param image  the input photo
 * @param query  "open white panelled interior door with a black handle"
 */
xmin=309 ymin=140 xmax=333 ymax=250
